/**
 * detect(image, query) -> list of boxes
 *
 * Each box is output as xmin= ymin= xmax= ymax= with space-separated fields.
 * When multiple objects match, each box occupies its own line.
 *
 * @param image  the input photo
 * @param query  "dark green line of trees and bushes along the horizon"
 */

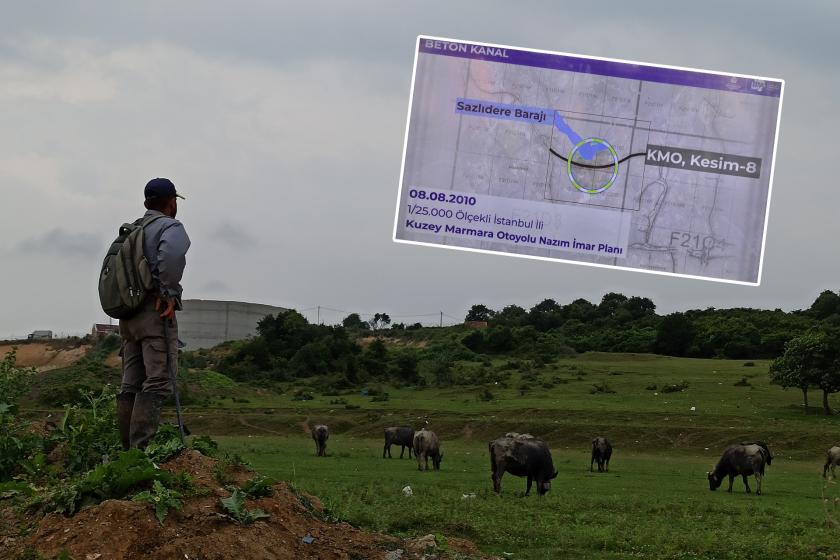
xmin=212 ymin=291 xmax=840 ymax=413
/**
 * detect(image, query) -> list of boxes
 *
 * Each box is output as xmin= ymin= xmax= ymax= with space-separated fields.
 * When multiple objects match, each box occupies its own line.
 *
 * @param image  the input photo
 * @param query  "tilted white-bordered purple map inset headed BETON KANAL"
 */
xmin=394 ymin=37 xmax=783 ymax=284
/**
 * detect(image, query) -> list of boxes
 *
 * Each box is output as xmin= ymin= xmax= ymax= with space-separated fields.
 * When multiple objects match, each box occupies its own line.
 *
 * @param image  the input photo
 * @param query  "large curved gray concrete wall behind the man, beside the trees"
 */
xmin=178 ymin=299 xmax=286 ymax=350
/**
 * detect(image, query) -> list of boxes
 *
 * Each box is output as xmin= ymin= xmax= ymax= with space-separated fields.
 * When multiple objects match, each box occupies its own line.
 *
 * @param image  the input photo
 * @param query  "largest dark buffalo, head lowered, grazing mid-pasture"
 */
xmin=490 ymin=434 xmax=557 ymax=496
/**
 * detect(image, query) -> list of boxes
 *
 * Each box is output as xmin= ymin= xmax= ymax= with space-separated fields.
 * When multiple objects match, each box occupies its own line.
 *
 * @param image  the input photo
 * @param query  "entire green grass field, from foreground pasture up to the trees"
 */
xmin=162 ymin=354 xmax=840 ymax=560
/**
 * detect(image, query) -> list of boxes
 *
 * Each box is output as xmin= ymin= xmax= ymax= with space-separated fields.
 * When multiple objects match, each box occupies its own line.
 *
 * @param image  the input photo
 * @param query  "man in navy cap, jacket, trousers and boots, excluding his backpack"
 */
xmin=117 ymin=178 xmax=190 ymax=450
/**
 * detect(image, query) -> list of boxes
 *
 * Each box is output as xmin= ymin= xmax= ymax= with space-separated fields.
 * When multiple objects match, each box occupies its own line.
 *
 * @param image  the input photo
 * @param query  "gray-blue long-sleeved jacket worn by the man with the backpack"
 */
xmin=143 ymin=210 xmax=190 ymax=309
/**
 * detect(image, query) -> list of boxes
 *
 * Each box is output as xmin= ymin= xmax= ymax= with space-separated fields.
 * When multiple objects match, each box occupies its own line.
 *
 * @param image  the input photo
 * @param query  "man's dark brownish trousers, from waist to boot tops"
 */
xmin=120 ymin=299 xmax=178 ymax=396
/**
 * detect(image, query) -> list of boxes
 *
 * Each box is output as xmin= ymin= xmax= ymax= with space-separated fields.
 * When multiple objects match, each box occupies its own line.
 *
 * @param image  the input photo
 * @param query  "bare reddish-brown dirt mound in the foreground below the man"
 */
xmin=11 ymin=450 xmax=488 ymax=560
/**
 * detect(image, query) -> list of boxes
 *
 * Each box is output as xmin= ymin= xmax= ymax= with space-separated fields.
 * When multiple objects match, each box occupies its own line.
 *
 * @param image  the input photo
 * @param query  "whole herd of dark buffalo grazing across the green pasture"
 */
xmin=312 ymin=424 xmax=840 ymax=496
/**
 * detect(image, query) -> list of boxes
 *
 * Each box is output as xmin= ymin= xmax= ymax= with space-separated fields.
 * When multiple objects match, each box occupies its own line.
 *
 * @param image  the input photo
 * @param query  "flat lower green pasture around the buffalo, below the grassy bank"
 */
xmin=219 ymin=434 xmax=840 ymax=559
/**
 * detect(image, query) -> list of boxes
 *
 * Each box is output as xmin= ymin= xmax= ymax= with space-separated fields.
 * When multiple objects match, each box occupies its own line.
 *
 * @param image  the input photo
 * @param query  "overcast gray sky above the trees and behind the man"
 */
xmin=0 ymin=0 xmax=840 ymax=338
